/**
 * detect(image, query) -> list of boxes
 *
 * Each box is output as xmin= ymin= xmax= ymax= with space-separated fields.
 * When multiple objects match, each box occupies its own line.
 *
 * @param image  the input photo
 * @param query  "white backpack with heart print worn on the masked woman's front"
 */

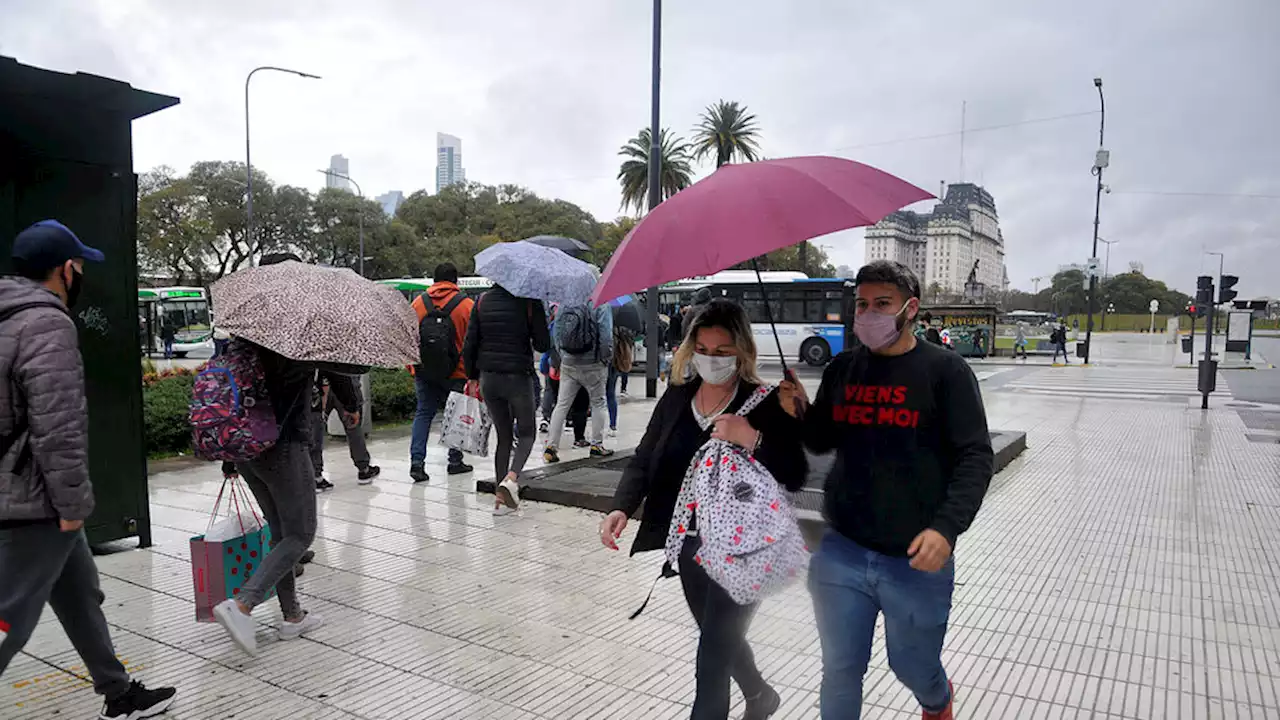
xmin=666 ymin=386 xmax=809 ymax=605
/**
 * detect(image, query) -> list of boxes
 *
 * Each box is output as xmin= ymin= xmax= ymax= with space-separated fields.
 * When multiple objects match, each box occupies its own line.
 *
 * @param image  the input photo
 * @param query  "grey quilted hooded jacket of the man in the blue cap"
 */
xmin=0 ymin=277 xmax=93 ymax=523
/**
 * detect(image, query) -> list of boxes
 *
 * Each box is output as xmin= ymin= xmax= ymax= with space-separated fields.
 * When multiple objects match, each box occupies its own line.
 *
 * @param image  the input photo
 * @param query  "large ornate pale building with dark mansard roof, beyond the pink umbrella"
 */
xmin=865 ymin=183 xmax=1007 ymax=295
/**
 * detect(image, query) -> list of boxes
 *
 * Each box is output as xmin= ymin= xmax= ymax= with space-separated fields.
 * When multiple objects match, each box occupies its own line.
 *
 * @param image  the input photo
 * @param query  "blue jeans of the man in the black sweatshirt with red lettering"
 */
xmin=809 ymin=529 xmax=955 ymax=720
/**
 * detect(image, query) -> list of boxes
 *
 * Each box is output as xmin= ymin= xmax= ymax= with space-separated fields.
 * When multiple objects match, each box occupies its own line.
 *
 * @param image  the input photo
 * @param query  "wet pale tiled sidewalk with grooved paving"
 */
xmin=0 ymin=369 xmax=1280 ymax=720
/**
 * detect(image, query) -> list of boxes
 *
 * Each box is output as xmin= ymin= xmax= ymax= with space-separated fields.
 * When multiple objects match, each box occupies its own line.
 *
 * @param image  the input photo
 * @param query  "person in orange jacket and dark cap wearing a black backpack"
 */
xmin=408 ymin=263 xmax=475 ymax=483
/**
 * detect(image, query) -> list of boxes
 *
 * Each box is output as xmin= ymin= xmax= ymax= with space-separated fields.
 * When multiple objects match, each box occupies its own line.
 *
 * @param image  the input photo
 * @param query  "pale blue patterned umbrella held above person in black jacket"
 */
xmin=476 ymin=241 xmax=600 ymax=305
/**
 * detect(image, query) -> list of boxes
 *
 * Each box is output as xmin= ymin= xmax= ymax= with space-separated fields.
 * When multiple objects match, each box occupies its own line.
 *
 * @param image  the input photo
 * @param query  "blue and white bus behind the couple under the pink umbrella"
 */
xmin=658 ymin=270 xmax=854 ymax=366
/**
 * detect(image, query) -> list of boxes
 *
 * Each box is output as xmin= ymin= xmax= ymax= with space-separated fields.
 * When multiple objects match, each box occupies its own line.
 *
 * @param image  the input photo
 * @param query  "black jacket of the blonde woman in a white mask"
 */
xmin=613 ymin=379 xmax=808 ymax=555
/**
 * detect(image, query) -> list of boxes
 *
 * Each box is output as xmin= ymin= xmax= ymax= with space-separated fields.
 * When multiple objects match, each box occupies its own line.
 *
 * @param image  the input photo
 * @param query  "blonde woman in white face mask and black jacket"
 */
xmin=600 ymin=300 xmax=806 ymax=720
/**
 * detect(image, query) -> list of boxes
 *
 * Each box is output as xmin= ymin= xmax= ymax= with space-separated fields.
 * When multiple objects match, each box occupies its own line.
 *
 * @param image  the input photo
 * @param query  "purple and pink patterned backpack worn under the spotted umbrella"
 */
xmin=189 ymin=341 xmax=280 ymax=461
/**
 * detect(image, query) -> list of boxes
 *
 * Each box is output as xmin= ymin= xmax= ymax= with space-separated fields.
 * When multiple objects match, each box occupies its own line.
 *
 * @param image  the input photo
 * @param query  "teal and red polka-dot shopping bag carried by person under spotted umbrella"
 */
xmin=191 ymin=478 xmax=275 ymax=623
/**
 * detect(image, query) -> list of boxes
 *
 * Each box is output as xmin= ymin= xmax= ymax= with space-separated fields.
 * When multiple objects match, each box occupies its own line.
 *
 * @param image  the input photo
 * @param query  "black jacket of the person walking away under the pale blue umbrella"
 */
xmin=462 ymin=287 xmax=550 ymax=380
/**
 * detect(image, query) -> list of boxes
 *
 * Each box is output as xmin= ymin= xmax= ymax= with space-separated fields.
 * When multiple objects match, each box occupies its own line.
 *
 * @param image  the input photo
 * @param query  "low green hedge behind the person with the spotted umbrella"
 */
xmin=142 ymin=369 xmax=417 ymax=456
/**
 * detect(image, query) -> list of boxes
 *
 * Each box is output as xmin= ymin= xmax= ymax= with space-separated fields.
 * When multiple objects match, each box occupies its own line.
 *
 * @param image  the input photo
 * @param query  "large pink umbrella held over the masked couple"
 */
xmin=591 ymin=156 xmax=933 ymax=305
